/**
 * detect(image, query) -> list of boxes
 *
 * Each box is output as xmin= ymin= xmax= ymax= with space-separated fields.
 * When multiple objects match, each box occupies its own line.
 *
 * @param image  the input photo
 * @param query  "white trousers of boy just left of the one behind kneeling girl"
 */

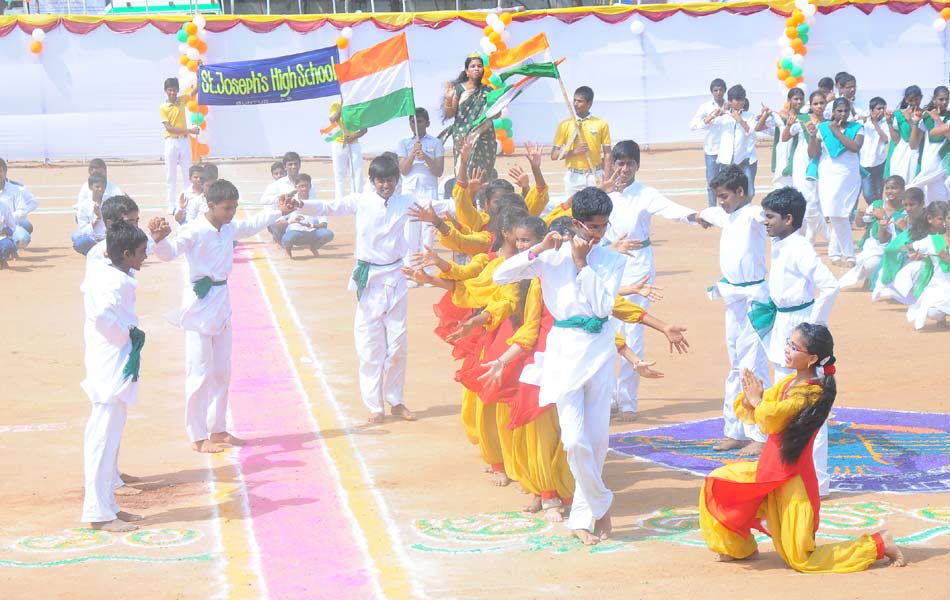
xmin=722 ymin=301 xmax=769 ymax=442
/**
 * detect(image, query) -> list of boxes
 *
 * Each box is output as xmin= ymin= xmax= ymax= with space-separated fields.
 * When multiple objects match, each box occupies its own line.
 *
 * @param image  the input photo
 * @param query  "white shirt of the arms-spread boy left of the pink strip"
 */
xmin=155 ymin=208 xmax=280 ymax=335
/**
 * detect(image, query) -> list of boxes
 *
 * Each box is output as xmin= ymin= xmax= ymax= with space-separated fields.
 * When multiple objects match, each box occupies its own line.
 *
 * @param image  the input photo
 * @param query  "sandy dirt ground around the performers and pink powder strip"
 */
xmin=0 ymin=149 xmax=950 ymax=600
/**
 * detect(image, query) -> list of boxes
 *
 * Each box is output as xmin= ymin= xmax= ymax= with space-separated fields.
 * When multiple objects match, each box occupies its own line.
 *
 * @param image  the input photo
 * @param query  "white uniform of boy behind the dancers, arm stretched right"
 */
xmin=606 ymin=181 xmax=696 ymax=412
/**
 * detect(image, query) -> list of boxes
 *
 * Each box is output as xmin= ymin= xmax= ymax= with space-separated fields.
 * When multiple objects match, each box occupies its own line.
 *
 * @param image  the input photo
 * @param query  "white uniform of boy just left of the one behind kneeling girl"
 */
xmin=699 ymin=204 xmax=769 ymax=442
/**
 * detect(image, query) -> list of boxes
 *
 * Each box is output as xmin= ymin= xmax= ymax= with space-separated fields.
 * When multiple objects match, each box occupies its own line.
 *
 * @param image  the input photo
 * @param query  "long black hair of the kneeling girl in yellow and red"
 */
xmin=781 ymin=323 xmax=838 ymax=465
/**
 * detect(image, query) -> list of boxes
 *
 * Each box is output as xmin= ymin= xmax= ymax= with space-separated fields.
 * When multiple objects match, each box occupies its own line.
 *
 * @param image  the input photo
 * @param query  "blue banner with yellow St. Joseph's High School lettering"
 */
xmin=198 ymin=46 xmax=340 ymax=106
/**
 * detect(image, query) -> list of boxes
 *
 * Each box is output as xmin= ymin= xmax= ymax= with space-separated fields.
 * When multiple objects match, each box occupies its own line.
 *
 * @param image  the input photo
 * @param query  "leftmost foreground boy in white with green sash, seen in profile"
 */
xmin=80 ymin=221 xmax=148 ymax=531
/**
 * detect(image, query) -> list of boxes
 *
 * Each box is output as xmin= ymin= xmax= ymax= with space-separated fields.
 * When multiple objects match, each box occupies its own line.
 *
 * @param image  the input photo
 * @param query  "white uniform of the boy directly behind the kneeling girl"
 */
xmin=762 ymin=233 xmax=839 ymax=496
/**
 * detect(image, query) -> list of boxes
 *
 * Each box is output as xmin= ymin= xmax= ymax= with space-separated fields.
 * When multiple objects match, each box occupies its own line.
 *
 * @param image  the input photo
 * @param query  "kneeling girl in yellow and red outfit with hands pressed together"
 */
xmin=699 ymin=323 xmax=905 ymax=573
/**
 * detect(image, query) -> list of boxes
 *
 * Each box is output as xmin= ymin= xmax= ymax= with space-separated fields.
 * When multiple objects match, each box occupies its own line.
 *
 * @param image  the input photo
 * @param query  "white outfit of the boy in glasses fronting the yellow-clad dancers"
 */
xmin=494 ymin=244 xmax=626 ymax=530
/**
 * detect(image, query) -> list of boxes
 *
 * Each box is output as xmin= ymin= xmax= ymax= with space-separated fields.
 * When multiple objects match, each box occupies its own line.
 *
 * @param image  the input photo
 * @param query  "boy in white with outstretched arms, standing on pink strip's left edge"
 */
xmin=149 ymin=179 xmax=296 ymax=453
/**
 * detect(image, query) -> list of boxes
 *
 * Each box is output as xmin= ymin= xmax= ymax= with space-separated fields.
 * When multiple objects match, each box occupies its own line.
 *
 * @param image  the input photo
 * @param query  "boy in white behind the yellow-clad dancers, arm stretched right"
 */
xmin=605 ymin=140 xmax=699 ymax=420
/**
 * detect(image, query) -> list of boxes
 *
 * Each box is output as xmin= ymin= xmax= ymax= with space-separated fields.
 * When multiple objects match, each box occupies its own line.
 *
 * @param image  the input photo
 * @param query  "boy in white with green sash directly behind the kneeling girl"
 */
xmin=749 ymin=188 xmax=839 ymax=496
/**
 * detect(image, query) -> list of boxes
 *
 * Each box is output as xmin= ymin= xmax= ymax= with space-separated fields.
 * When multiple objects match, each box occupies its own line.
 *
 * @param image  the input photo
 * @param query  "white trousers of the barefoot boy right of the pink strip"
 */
xmin=353 ymin=279 xmax=409 ymax=414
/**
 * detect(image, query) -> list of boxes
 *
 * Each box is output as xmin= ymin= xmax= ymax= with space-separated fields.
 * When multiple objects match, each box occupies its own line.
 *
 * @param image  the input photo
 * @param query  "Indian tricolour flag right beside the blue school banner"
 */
xmin=335 ymin=33 xmax=416 ymax=130
